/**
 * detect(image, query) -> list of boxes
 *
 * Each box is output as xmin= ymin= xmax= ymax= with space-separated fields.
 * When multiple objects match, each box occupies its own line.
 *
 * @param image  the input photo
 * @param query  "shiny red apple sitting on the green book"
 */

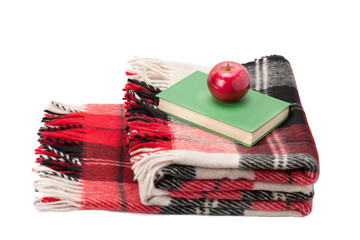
xmin=207 ymin=61 xmax=250 ymax=102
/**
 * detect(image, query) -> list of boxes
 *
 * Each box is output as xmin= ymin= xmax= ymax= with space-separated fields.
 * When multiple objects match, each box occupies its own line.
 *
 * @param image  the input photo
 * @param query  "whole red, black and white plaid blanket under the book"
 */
xmin=34 ymin=56 xmax=319 ymax=216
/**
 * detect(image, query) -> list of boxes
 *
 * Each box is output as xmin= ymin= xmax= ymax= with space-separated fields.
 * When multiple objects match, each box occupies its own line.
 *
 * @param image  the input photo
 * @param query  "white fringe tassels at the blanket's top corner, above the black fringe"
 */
xmin=128 ymin=57 xmax=171 ymax=90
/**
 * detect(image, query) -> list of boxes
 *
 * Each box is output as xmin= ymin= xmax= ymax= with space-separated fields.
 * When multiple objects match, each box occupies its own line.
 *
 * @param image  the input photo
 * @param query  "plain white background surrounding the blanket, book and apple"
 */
xmin=0 ymin=0 xmax=360 ymax=239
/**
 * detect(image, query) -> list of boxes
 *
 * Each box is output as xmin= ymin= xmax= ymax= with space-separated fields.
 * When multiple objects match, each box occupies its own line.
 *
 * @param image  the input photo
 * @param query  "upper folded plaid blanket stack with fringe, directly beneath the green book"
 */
xmin=125 ymin=56 xmax=319 ymax=216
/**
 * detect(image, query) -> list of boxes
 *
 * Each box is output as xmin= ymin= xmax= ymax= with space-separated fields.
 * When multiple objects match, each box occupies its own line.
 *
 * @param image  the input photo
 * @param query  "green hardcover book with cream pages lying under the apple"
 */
xmin=156 ymin=71 xmax=290 ymax=147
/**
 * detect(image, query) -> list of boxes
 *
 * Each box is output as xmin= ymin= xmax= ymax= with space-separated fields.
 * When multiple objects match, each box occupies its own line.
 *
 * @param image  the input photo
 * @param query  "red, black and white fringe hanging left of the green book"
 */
xmin=124 ymin=79 xmax=174 ymax=186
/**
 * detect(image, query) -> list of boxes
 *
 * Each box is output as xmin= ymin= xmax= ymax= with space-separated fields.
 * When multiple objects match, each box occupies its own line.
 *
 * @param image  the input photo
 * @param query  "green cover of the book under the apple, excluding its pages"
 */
xmin=157 ymin=71 xmax=290 ymax=146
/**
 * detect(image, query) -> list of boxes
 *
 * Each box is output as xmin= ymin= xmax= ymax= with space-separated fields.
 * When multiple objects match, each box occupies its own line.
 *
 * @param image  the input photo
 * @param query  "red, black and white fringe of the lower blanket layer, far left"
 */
xmin=33 ymin=101 xmax=85 ymax=211
